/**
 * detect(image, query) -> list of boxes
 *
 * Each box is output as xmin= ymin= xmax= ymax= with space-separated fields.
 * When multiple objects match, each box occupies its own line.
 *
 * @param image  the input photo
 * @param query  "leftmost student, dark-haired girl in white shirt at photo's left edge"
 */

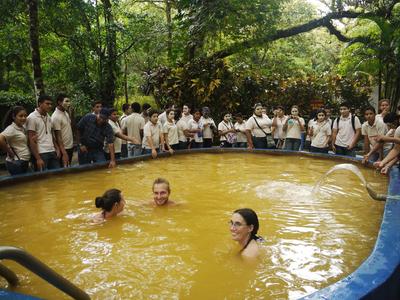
xmin=0 ymin=106 xmax=31 ymax=175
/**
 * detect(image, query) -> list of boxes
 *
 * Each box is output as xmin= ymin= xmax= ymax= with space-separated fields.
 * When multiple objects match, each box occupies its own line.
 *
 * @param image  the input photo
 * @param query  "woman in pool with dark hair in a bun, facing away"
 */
xmin=94 ymin=189 xmax=125 ymax=222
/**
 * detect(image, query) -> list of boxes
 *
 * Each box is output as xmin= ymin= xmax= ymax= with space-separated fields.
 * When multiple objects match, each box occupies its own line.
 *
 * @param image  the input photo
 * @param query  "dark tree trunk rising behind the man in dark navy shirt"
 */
xmin=101 ymin=0 xmax=117 ymax=107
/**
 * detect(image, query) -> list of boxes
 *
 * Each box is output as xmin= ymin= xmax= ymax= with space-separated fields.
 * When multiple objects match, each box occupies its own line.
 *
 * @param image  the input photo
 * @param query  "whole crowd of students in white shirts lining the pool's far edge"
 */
xmin=0 ymin=95 xmax=400 ymax=175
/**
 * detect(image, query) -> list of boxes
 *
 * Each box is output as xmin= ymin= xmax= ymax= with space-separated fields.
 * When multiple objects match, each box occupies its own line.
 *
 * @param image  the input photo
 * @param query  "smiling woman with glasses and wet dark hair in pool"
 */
xmin=229 ymin=208 xmax=264 ymax=258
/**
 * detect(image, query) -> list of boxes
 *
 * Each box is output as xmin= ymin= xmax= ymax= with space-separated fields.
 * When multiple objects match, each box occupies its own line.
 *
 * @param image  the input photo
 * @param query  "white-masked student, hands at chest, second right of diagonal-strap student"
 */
xmin=283 ymin=105 xmax=305 ymax=151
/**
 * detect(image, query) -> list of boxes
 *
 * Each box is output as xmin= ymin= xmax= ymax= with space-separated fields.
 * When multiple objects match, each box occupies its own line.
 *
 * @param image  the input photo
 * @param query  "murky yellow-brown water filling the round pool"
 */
xmin=0 ymin=154 xmax=386 ymax=299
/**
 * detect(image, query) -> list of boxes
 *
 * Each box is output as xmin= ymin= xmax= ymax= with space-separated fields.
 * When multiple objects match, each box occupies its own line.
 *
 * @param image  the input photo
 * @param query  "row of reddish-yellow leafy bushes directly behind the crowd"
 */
xmin=148 ymin=60 xmax=371 ymax=116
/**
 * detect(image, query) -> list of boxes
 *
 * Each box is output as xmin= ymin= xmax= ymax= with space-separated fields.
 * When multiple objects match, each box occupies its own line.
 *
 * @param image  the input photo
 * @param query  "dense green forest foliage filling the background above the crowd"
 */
xmin=0 ymin=0 xmax=400 ymax=114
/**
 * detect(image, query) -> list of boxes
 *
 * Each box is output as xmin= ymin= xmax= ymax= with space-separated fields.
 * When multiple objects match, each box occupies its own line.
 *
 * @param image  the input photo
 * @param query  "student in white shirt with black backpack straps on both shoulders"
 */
xmin=332 ymin=102 xmax=361 ymax=157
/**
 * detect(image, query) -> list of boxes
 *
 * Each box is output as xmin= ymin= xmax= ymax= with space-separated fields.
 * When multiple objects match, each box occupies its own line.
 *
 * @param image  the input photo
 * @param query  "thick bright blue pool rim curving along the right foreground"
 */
xmin=302 ymin=166 xmax=400 ymax=300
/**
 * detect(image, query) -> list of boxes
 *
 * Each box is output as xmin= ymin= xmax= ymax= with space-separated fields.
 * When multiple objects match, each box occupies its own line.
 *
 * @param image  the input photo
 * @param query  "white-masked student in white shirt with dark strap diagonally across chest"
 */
xmin=246 ymin=103 xmax=272 ymax=149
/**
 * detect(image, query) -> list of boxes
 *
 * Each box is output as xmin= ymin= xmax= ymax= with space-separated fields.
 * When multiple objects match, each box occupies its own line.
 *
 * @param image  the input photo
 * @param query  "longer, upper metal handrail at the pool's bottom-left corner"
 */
xmin=0 ymin=246 xmax=90 ymax=300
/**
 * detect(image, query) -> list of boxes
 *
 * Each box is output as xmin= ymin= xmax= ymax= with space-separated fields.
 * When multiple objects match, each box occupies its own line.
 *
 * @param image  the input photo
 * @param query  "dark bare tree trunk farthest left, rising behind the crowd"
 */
xmin=27 ymin=0 xmax=44 ymax=98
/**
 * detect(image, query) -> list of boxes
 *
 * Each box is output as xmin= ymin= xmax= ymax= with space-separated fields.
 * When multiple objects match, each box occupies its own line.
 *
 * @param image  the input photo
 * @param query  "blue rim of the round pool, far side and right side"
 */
xmin=0 ymin=148 xmax=400 ymax=299
